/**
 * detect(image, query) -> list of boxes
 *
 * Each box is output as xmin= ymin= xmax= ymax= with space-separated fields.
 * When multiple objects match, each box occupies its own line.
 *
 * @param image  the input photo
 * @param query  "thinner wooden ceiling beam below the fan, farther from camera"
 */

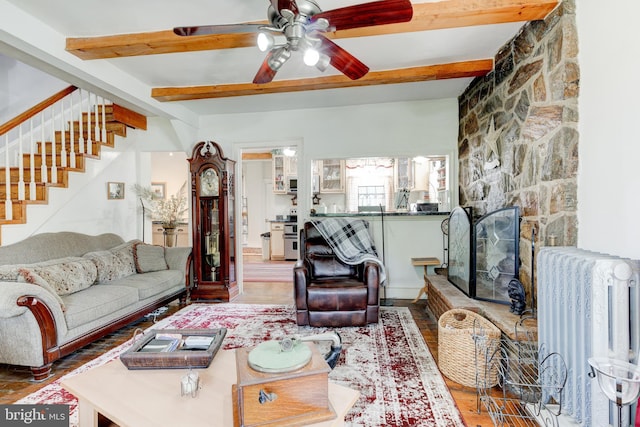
xmin=151 ymin=59 xmax=493 ymax=102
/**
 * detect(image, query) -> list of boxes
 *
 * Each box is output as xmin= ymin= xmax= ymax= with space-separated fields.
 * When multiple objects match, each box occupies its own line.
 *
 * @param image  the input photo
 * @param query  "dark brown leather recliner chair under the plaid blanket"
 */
xmin=293 ymin=222 xmax=380 ymax=327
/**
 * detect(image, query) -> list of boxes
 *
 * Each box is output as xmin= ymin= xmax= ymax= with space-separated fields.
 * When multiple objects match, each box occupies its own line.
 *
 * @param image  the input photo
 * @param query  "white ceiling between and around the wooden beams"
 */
xmin=0 ymin=0 xmax=540 ymax=117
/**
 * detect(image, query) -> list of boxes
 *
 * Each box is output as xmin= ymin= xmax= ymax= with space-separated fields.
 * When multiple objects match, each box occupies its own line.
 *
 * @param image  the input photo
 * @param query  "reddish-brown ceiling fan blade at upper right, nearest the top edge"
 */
xmin=311 ymin=0 xmax=413 ymax=30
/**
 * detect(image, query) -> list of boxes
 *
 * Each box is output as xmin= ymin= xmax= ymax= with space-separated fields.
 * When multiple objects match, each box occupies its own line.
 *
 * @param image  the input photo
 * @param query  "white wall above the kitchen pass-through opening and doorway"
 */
xmin=199 ymin=99 xmax=458 ymax=222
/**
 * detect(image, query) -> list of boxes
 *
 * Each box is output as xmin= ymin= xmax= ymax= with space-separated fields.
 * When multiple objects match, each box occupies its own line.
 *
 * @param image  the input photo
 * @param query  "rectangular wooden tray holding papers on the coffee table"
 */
xmin=120 ymin=328 xmax=227 ymax=369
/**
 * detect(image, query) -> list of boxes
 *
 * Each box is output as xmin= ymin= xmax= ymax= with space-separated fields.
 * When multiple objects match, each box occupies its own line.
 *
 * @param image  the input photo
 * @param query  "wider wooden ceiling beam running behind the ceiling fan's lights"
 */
xmin=66 ymin=0 xmax=559 ymax=60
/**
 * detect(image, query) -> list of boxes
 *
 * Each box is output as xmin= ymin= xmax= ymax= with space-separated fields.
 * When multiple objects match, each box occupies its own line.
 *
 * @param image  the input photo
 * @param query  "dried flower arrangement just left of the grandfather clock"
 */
xmin=133 ymin=181 xmax=188 ymax=227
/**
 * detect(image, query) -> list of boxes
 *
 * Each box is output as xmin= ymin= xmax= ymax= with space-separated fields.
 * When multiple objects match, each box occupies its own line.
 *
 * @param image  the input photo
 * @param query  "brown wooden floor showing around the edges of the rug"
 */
xmin=0 ymin=258 xmax=493 ymax=427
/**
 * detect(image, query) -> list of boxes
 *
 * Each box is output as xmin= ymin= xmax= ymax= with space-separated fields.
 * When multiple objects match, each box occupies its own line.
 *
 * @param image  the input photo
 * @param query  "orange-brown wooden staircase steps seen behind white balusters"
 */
xmin=0 ymin=89 xmax=147 ymax=241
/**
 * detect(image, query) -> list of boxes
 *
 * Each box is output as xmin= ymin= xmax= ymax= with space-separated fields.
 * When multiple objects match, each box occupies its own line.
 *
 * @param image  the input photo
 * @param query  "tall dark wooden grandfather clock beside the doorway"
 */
xmin=188 ymin=141 xmax=238 ymax=301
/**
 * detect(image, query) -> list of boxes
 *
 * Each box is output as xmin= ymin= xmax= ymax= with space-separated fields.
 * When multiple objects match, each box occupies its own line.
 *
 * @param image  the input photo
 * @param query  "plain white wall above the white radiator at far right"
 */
xmin=576 ymin=0 xmax=640 ymax=259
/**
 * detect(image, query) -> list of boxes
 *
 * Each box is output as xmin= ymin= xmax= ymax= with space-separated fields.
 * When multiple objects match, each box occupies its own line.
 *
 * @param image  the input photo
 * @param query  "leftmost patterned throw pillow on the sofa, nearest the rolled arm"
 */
xmin=25 ymin=257 xmax=98 ymax=295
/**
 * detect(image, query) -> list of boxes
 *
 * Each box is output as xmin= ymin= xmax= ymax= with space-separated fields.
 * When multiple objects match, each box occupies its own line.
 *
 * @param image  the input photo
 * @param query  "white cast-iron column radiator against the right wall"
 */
xmin=537 ymin=247 xmax=640 ymax=427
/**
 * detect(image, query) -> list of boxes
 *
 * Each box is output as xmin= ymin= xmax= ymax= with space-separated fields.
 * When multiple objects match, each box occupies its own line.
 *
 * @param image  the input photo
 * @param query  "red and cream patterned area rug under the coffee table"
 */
xmin=16 ymin=304 xmax=465 ymax=427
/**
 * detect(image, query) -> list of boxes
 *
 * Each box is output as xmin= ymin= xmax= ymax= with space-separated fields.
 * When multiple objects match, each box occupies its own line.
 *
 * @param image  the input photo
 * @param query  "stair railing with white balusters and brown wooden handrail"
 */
xmin=0 ymin=86 xmax=112 ymax=221
